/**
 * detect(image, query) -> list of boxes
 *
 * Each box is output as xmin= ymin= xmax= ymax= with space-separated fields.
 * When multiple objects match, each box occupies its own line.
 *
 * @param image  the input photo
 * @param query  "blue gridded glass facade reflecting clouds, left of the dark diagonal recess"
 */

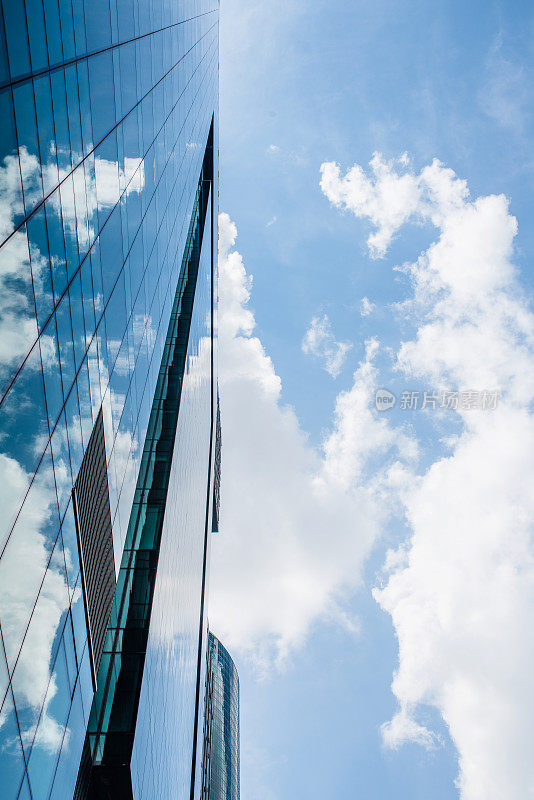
xmin=0 ymin=0 xmax=218 ymax=800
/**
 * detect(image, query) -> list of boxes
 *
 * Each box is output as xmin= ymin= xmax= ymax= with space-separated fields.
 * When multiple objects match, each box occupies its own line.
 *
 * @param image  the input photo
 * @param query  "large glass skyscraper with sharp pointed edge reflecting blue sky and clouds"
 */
xmin=0 ymin=0 xmax=220 ymax=800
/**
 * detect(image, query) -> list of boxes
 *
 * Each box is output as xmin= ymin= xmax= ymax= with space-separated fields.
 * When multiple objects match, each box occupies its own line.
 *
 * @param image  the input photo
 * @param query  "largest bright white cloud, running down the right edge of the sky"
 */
xmin=323 ymin=156 xmax=534 ymax=800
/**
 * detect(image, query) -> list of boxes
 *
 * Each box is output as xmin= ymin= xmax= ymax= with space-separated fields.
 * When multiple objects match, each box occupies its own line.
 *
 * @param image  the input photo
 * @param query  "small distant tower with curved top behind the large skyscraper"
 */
xmin=202 ymin=632 xmax=240 ymax=800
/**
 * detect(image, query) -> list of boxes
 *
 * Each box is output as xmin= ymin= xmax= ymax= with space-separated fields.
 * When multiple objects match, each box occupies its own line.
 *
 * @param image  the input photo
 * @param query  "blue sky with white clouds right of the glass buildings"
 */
xmin=209 ymin=0 xmax=534 ymax=800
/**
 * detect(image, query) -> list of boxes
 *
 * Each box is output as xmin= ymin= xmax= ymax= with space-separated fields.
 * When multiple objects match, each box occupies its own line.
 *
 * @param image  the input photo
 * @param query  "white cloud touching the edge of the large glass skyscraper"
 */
xmin=210 ymin=214 xmax=412 ymax=665
